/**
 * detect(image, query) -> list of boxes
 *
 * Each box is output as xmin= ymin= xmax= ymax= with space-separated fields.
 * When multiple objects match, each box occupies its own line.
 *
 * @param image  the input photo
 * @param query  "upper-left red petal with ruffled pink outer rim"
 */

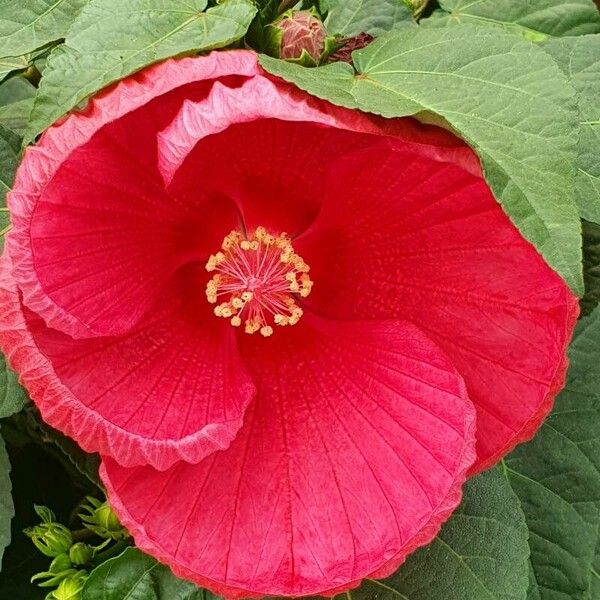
xmin=8 ymin=51 xmax=258 ymax=337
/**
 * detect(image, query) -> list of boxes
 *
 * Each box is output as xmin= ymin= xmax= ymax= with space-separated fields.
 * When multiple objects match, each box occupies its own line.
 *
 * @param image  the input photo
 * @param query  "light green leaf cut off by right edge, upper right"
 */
xmin=544 ymin=35 xmax=600 ymax=223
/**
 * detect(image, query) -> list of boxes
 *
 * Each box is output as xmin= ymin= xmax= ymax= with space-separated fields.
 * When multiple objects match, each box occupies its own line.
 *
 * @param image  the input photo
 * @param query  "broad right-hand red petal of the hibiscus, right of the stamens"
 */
xmin=295 ymin=144 xmax=578 ymax=471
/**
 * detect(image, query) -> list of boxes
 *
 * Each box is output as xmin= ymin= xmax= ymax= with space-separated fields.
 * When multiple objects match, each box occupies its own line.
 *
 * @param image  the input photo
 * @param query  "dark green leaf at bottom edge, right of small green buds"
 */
xmin=82 ymin=548 xmax=216 ymax=600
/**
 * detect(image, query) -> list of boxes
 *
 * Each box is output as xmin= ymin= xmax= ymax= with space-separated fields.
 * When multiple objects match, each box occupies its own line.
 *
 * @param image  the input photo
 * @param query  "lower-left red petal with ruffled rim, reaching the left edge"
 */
xmin=0 ymin=253 xmax=255 ymax=469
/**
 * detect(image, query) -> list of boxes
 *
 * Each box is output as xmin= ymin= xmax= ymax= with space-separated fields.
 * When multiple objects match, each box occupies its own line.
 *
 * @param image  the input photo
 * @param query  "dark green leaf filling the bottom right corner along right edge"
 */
xmin=505 ymin=309 xmax=600 ymax=600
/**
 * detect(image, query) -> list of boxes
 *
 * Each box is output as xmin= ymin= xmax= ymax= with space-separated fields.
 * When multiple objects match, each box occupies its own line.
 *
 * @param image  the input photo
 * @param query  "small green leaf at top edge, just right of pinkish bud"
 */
xmin=325 ymin=0 xmax=415 ymax=37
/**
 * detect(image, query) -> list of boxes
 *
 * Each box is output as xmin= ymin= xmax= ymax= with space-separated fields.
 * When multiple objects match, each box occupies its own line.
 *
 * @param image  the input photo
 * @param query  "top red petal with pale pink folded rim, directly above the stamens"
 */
xmin=158 ymin=76 xmax=477 ymax=236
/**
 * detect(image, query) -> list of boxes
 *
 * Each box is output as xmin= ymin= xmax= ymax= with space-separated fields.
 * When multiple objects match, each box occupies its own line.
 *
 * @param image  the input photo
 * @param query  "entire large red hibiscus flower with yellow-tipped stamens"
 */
xmin=0 ymin=51 xmax=577 ymax=598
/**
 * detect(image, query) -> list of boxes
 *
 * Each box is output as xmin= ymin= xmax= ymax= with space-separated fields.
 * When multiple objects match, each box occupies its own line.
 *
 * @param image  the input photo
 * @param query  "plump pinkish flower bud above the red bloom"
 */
xmin=266 ymin=10 xmax=334 ymax=66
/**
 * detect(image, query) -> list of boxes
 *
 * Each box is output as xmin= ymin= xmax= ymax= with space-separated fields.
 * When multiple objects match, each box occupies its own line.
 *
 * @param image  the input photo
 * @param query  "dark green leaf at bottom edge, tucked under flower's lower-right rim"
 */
xmin=280 ymin=470 xmax=529 ymax=600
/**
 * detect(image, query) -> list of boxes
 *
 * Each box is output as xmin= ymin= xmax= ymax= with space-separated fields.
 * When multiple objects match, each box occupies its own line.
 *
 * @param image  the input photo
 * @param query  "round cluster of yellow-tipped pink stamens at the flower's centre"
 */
xmin=206 ymin=227 xmax=313 ymax=337
